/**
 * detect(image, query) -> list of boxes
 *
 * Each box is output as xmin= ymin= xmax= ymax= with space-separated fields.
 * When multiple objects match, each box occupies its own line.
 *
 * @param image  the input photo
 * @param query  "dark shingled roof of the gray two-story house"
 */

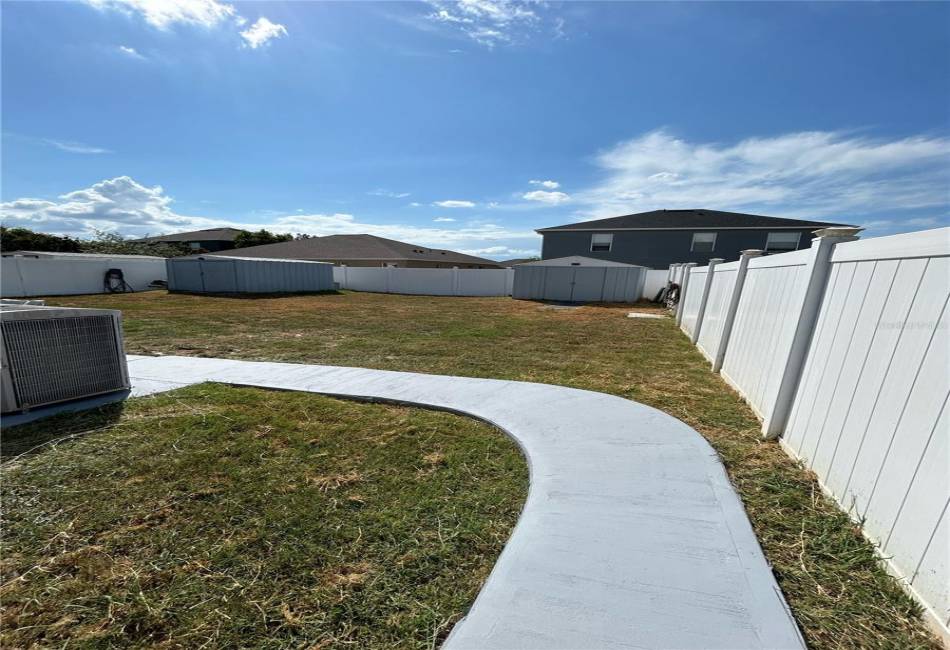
xmin=537 ymin=210 xmax=848 ymax=233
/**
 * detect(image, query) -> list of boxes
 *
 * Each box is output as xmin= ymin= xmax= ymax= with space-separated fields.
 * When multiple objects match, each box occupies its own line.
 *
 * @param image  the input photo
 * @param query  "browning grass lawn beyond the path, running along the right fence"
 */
xmin=7 ymin=292 xmax=937 ymax=648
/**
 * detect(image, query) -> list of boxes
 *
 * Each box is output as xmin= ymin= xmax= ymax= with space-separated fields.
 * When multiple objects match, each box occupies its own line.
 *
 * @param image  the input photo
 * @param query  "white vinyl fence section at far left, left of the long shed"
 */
xmin=0 ymin=255 xmax=166 ymax=298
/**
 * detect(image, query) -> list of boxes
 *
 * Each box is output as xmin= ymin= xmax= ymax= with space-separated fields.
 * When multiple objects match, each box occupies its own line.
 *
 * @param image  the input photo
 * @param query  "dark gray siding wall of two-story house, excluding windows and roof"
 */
xmin=541 ymin=227 xmax=815 ymax=269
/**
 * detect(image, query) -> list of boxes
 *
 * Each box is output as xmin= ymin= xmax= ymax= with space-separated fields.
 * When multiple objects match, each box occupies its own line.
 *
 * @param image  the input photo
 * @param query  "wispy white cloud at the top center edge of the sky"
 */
xmin=426 ymin=0 xmax=563 ymax=49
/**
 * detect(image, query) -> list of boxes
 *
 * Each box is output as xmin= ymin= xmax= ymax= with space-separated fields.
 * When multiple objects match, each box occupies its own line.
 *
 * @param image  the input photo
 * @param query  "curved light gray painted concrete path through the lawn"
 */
xmin=129 ymin=356 xmax=804 ymax=650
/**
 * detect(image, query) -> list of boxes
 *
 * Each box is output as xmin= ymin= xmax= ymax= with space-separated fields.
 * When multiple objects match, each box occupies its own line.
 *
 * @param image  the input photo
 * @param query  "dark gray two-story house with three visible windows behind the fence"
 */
xmin=537 ymin=210 xmax=847 ymax=269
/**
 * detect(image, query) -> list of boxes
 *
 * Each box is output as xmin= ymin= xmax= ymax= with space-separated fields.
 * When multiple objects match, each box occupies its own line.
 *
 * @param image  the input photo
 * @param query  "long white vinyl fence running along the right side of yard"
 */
xmin=680 ymin=228 xmax=950 ymax=638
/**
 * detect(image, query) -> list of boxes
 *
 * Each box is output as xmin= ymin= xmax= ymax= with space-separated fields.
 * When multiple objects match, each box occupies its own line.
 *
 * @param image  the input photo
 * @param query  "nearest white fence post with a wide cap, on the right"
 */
xmin=762 ymin=228 xmax=862 ymax=438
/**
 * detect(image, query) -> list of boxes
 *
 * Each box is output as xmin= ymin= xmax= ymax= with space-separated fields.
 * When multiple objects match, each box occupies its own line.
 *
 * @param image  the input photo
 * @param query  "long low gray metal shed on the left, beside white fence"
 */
xmin=165 ymin=255 xmax=333 ymax=293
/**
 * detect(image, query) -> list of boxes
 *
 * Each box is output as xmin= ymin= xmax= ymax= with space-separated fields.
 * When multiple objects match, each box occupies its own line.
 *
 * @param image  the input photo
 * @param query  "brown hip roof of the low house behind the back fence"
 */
xmin=215 ymin=235 xmax=499 ymax=267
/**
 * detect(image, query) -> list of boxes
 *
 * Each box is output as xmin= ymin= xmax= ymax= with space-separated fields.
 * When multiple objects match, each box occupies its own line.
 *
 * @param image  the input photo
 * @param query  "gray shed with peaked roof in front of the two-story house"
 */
xmin=512 ymin=255 xmax=647 ymax=302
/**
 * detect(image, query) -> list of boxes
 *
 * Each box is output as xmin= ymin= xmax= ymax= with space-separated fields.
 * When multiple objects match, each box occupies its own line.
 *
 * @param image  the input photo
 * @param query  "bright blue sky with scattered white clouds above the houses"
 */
xmin=0 ymin=0 xmax=950 ymax=259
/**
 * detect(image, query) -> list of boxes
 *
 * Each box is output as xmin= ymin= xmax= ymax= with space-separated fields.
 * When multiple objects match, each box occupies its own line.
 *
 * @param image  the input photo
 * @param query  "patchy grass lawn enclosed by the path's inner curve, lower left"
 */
xmin=0 ymin=384 xmax=527 ymax=648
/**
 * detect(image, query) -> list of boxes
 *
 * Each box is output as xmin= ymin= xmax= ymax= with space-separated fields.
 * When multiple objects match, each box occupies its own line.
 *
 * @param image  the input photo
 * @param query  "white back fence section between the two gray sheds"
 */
xmin=333 ymin=266 xmax=514 ymax=296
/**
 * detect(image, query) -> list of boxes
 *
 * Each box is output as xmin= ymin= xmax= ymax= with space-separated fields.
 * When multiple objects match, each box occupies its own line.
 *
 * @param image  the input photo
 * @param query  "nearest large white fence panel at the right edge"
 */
xmin=783 ymin=229 xmax=950 ymax=631
